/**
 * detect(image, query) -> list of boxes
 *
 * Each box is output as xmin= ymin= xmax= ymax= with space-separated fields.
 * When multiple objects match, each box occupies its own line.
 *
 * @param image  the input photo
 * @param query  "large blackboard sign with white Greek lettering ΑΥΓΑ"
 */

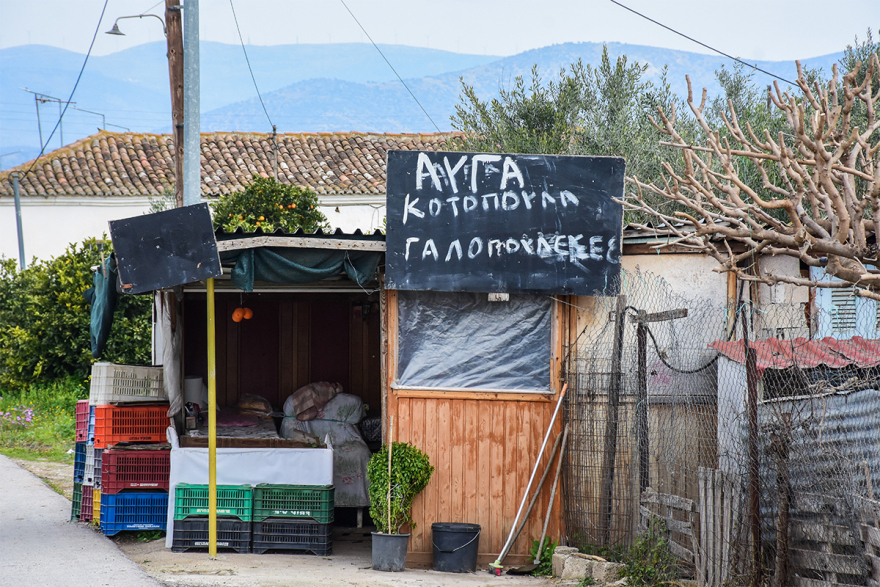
xmin=385 ymin=151 xmax=625 ymax=295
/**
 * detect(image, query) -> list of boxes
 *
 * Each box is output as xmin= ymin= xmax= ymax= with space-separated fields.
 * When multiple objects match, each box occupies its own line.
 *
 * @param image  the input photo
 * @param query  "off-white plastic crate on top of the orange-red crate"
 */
xmin=89 ymin=363 xmax=168 ymax=406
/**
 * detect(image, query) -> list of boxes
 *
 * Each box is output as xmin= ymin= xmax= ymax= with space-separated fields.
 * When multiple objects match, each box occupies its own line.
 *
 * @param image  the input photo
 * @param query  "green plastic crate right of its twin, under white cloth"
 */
xmin=254 ymin=483 xmax=334 ymax=524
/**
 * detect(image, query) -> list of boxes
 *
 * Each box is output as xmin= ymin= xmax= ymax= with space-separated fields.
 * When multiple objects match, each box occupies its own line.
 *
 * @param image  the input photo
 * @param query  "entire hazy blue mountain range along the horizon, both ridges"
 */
xmin=0 ymin=42 xmax=842 ymax=168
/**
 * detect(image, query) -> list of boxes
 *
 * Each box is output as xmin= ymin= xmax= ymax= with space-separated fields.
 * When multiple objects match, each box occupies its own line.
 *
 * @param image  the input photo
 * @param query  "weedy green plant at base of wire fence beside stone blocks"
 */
xmin=623 ymin=518 xmax=678 ymax=587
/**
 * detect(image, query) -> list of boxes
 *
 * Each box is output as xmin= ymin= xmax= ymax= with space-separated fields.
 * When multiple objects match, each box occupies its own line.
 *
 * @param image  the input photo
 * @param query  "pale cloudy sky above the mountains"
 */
xmin=0 ymin=0 xmax=880 ymax=61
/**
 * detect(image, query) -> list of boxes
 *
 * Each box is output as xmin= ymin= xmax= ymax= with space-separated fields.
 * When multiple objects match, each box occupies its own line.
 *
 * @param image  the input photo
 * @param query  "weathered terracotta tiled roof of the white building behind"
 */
xmin=0 ymin=131 xmax=451 ymax=197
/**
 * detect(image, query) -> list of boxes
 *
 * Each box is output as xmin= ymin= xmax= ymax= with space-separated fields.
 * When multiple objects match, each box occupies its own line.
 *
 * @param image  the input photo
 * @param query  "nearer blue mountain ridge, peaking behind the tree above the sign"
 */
xmin=203 ymin=43 xmax=843 ymax=132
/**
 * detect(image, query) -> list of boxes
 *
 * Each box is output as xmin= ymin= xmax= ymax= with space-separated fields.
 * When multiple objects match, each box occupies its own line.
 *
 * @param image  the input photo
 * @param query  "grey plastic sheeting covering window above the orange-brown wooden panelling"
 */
xmin=397 ymin=291 xmax=553 ymax=393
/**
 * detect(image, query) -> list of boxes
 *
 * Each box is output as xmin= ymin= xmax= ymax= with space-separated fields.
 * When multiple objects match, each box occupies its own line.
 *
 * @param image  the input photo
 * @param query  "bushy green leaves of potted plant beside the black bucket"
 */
xmin=367 ymin=442 xmax=434 ymax=534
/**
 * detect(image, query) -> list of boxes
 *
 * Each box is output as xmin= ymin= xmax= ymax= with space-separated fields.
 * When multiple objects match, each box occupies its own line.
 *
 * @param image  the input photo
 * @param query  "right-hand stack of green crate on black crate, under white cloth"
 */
xmin=251 ymin=484 xmax=335 ymax=556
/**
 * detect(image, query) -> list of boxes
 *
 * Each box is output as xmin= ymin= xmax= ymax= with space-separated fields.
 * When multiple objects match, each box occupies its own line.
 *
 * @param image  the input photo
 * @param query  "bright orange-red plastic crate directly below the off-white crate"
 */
xmin=95 ymin=404 xmax=168 ymax=450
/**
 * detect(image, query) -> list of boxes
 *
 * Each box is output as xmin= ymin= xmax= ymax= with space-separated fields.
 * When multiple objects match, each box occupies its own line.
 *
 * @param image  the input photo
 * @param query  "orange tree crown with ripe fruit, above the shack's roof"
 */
xmin=211 ymin=175 xmax=327 ymax=232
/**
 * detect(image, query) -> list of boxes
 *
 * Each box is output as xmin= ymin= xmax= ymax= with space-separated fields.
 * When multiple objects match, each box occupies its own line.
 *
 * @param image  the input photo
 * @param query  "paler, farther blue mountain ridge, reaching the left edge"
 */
xmin=0 ymin=42 xmax=498 ymax=168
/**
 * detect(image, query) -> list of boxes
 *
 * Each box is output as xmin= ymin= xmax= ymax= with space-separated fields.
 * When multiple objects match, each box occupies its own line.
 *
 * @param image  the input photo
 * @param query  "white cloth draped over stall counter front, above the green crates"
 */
xmin=165 ymin=427 xmax=333 ymax=548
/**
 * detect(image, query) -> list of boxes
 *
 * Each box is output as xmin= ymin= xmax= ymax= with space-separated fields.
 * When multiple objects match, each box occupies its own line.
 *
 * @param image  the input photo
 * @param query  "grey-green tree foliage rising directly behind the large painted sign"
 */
xmin=452 ymin=47 xmax=699 ymax=220
